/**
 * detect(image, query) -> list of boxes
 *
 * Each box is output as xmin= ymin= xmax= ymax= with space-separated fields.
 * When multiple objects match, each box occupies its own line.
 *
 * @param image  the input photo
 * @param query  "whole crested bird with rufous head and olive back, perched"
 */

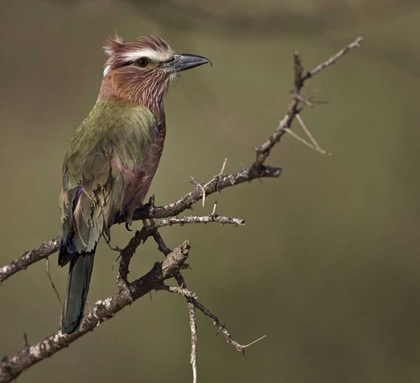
xmin=58 ymin=35 xmax=211 ymax=334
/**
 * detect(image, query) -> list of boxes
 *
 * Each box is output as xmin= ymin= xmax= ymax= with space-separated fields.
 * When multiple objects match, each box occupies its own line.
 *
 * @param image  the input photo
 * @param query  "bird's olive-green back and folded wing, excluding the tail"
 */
xmin=59 ymin=104 xmax=156 ymax=265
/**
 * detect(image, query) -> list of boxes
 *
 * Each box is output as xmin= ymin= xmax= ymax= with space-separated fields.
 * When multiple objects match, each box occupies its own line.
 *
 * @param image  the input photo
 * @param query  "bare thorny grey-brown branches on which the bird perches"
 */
xmin=0 ymin=37 xmax=362 ymax=382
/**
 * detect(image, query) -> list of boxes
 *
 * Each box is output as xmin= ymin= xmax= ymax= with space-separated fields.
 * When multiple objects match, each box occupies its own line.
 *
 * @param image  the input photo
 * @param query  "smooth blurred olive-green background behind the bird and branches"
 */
xmin=0 ymin=0 xmax=420 ymax=383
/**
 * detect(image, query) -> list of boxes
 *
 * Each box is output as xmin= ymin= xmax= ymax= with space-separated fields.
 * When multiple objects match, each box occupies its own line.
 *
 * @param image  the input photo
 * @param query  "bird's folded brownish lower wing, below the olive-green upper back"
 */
xmin=59 ymin=147 xmax=124 ymax=264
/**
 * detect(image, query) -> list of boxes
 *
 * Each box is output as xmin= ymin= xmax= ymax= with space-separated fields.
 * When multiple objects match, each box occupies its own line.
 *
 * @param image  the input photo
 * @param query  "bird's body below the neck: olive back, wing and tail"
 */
xmin=59 ymin=100 xmax=159 ymax=332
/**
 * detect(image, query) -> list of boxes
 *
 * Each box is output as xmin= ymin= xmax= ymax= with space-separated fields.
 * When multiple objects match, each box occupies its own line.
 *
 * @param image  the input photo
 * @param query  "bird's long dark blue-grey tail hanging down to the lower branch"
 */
xmin=61 ymin=250 xmax=95 ymax=334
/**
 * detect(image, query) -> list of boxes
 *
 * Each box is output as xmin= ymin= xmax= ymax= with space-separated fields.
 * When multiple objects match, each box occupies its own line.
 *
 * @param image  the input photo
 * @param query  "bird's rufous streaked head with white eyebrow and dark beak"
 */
xmin=100 ymin=36 xmax=211 ymax=109
